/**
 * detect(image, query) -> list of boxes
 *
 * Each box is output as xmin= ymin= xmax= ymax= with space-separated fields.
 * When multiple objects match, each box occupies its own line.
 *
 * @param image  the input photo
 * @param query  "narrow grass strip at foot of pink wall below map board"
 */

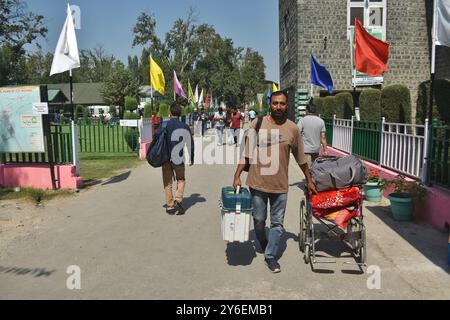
xmin=0 ymin=188 xmax=74 ymax=204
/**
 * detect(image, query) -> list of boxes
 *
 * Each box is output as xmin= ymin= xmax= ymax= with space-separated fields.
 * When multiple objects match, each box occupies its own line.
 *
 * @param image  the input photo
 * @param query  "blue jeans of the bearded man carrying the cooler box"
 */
xmin=250 ymin=189 xmax=287 ymax=259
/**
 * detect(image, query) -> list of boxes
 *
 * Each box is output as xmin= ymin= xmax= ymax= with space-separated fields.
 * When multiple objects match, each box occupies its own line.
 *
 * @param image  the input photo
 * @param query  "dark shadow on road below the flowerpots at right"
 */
xmin=367 ymin=205 xmax=450 ymax=274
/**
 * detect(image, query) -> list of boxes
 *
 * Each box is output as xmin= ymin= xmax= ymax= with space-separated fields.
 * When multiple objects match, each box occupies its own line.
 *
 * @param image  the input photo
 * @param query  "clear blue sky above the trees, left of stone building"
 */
xmin=25 ymin=0 xmax=279 ymax=83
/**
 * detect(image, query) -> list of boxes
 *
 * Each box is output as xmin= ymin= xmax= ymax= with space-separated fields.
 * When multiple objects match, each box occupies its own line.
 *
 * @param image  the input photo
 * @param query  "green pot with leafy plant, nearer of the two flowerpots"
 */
xmin=385 ymin=175 xmax=428 ymax=221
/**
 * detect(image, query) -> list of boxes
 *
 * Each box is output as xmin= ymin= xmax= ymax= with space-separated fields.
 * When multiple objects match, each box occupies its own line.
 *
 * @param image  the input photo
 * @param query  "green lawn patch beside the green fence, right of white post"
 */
xmin=80 ymin=153 xmax=143 ymax=185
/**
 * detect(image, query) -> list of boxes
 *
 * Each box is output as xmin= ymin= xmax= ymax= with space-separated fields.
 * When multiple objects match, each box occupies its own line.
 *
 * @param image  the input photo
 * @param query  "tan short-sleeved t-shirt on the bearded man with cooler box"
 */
xmin=244 ymin=117 xmax=306 ymax=194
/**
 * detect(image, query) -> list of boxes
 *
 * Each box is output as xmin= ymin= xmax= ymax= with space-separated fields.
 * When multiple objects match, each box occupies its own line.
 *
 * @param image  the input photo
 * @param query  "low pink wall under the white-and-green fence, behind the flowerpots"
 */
xmin=328 ymin=147 xmax=450 ymax=231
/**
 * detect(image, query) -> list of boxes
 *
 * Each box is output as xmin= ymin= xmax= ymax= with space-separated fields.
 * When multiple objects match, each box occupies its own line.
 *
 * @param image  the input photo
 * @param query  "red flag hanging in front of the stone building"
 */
xmin=355 ymin=19 xmax=389 ymax=77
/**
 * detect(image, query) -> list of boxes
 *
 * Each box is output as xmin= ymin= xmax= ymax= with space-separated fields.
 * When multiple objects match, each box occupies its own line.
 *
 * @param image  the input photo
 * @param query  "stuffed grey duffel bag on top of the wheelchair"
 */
xmin=311 ymin=156 xmax=368 ymax=192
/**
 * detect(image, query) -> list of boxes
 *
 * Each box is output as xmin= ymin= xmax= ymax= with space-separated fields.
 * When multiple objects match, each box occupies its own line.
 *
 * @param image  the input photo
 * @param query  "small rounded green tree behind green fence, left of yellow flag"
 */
xmin=101 ymin=61 xmax=139 ymax=118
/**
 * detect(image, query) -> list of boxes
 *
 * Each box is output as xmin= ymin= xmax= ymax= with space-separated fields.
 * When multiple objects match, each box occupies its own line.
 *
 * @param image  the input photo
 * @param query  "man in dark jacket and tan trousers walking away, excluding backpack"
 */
xmin=154 ymin=102 xmax=194 ymax=215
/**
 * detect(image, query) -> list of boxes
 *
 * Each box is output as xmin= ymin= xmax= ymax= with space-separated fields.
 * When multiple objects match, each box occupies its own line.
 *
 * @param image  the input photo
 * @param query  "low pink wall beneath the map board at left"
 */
xmin=0 ymin=164 xmax=83 ymax=190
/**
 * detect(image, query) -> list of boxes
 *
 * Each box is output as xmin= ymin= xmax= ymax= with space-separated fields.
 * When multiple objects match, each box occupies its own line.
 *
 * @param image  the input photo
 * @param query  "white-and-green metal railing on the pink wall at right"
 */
xmin=325 ymin=117 xmax=428 ymax=184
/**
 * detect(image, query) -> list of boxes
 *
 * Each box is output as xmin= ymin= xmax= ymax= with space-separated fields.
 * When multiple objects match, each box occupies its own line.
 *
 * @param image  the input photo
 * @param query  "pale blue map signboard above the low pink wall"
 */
xmin=0 ymin=86 xmax=45 ymax=153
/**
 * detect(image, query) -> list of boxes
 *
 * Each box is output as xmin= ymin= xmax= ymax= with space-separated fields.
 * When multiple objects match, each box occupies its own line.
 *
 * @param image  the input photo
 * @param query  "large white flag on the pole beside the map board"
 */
xmin=50 ymin=5 xmax=80 ymax=76
